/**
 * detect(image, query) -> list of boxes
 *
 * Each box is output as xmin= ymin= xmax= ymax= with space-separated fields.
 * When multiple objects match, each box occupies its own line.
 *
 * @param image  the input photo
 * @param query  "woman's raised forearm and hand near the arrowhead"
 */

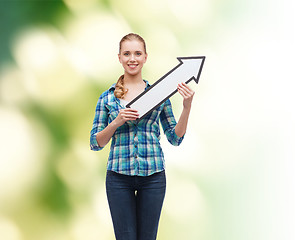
xmin=175 ymin=83 xmax=195 ymax=137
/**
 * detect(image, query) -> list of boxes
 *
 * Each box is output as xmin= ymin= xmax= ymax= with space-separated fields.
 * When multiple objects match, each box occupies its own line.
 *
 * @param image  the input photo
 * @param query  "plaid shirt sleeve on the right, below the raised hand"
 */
xmin=160 ymin=99 xmax=184 ymax=146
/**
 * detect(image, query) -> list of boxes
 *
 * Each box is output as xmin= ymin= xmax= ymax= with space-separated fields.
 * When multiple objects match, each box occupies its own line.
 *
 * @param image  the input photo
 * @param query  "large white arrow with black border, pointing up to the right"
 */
xmin=126 ymin=56 xmax=205 ymax=119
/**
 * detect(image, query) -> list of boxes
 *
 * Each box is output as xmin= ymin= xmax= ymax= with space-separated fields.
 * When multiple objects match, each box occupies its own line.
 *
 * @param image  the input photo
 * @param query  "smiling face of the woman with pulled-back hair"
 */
xmin=118 ymin=40 xmax=147 ymax=76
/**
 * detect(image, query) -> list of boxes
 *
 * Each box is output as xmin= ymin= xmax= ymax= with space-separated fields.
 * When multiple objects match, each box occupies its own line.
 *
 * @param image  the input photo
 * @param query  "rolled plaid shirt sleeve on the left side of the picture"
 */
xmin=90 ymin=94 xmax=108 ymax=151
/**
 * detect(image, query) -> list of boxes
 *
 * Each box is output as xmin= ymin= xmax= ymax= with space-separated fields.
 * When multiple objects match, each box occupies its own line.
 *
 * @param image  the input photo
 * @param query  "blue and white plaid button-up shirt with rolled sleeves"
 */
xmin=90 ymin=81 xmax=183 ymax=176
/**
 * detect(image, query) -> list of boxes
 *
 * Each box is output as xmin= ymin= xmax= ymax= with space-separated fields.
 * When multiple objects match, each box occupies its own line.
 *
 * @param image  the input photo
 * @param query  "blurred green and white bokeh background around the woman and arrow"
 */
xmin=0 ymin=0 xmax=295 ymax=240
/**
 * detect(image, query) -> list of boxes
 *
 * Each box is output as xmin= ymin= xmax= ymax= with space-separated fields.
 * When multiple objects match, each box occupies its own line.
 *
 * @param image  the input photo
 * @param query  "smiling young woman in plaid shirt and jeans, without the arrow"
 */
xmin=90 ymin=33 xmax=194 ymax=240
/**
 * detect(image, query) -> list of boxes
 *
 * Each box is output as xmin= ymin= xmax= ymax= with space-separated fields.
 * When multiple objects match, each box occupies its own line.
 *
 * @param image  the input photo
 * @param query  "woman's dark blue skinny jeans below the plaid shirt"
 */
xmin=106 ymin=171 xmax=166 ymax=240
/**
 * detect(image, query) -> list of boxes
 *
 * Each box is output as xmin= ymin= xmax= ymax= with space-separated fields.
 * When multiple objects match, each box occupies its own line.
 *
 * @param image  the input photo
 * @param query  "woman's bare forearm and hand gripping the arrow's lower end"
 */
xmin=96 ymin=108 xmax=139 ymax=147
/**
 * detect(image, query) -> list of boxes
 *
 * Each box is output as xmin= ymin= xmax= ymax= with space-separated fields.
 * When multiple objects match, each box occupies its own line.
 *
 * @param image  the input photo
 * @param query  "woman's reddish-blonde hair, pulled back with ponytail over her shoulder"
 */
xmin=114 ymin=33 xmax=146 ymax=98
